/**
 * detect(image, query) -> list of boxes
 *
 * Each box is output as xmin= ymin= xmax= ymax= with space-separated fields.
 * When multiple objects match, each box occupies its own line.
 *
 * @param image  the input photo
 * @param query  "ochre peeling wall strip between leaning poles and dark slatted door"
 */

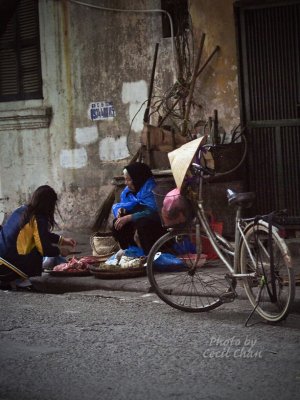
xmin=190 ymin=0 xmax=240 ymax=132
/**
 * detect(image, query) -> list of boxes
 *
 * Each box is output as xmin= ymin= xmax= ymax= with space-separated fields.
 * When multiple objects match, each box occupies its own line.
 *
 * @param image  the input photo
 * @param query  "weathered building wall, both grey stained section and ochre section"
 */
xmin=0 ymin=0 xmax=239 ymax=229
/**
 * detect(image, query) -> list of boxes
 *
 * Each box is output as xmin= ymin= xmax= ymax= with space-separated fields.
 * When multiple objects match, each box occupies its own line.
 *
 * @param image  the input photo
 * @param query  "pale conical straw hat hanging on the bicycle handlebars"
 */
xmin=168 ymin=135 xmax=207 ymax=189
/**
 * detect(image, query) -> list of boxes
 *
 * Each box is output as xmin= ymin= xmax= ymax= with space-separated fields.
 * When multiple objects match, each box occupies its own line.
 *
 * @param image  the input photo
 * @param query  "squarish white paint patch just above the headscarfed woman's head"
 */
xmin=99 ymin=136 xmax=129 ymax=161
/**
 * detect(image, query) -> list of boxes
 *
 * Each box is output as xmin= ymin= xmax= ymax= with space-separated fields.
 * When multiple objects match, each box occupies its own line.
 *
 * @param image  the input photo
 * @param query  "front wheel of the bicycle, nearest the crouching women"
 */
xmin=147 ymin=230 xmax=232 ymax=312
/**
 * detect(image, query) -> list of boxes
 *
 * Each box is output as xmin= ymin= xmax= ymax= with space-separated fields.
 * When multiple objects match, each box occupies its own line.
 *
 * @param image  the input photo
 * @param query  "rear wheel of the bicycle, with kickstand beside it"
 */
xmin=239 ymin=223 xmax=295 ymax=322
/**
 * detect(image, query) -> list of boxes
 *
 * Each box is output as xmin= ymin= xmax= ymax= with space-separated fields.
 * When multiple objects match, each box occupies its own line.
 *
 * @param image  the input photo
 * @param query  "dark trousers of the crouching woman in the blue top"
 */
xmin=112 ymin=215 xmax=166 ymax=254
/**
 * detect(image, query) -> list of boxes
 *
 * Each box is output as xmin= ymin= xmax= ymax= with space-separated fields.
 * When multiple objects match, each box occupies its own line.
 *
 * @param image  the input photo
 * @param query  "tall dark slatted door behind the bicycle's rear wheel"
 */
xmin=234 ymin=0 xmax=300 ymax=215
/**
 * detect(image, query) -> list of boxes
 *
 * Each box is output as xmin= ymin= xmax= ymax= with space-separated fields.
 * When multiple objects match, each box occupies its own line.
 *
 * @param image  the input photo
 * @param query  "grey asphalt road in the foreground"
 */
xmin=0 ymin=291 xmax=300 ymax=400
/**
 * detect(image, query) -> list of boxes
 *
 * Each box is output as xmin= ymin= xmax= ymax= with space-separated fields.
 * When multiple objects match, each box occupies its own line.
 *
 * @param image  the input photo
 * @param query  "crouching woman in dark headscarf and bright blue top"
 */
xmin=112 ymin=162 xmax=165 ymax=254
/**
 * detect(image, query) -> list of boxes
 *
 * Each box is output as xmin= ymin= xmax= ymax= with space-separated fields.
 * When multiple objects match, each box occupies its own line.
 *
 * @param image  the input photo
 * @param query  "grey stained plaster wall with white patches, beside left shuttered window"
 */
xmin=0 ymin=0 xmax=172 ymax=229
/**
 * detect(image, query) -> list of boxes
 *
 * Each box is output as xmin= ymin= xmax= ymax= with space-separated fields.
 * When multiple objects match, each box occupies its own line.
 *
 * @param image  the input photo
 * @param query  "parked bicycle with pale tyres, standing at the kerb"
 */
xmin=147 ymin=138 xmax=295 ymax=322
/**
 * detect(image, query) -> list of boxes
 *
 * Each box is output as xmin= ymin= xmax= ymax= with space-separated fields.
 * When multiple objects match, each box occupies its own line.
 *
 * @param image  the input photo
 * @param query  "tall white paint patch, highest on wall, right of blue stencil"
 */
xmin=122 ymin=80 xmax=148 ymax=132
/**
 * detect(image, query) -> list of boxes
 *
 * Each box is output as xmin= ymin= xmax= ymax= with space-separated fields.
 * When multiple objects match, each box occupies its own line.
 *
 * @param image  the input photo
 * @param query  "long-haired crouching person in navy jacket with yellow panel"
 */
xmin=0 ymin=185 xmax=76 ymax=281
